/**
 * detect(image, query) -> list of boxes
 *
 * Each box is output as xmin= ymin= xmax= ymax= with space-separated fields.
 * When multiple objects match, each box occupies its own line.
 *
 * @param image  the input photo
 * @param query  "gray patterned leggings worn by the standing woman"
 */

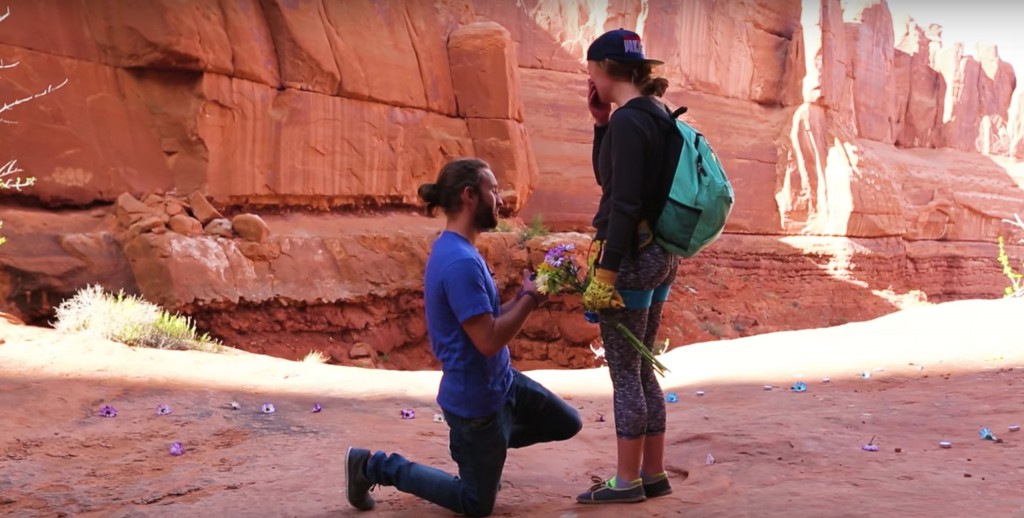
xmin=601 ymin=244 xmax=679 ymax=439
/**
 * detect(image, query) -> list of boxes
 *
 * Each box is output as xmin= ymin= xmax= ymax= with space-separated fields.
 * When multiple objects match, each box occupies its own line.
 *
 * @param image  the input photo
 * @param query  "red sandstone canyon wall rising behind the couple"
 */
xmin=0 ymin=0 xmax=1024 ymax=368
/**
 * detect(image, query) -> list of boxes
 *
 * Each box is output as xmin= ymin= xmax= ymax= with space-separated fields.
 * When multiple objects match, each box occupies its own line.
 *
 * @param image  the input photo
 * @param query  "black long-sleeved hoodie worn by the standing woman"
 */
xmin=593 ymin=97 xmax=683 ymax=271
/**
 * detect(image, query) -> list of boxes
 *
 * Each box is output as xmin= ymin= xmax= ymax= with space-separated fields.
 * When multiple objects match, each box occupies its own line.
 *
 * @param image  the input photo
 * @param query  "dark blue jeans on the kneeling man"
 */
xmin=367 ymin=371 xmax=583 ymax=516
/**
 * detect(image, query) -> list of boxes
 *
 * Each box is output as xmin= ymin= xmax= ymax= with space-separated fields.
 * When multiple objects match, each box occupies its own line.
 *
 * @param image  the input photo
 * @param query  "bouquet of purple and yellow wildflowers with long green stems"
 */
xmin=535 ymin=243 xmax=669 ymax=377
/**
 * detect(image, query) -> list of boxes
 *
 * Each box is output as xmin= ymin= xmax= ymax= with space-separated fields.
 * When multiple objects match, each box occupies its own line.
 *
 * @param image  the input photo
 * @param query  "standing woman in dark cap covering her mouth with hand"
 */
xmin=577 ymin=29 xmax=682 ymax=504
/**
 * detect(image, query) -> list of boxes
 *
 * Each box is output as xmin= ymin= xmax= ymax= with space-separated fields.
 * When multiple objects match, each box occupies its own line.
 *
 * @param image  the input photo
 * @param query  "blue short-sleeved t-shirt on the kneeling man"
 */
xmin=424 ymin=231 xmax=512 ymax=419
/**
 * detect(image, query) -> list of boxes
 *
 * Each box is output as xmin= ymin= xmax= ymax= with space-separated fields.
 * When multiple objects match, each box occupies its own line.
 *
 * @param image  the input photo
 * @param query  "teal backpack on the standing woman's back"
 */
xmin=652 ymin=106 xmax=735 ymax=257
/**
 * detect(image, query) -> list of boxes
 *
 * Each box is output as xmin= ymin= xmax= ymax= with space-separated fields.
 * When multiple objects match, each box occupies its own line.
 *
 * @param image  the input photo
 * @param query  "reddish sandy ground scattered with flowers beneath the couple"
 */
xmin=0 ymin=301 xmax=1024 ymax=517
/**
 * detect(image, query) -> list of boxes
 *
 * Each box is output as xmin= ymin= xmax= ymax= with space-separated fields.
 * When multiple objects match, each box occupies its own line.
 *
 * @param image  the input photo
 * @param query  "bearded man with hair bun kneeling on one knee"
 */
xmin=345 ymin=159 xmax=583 ymax=516
